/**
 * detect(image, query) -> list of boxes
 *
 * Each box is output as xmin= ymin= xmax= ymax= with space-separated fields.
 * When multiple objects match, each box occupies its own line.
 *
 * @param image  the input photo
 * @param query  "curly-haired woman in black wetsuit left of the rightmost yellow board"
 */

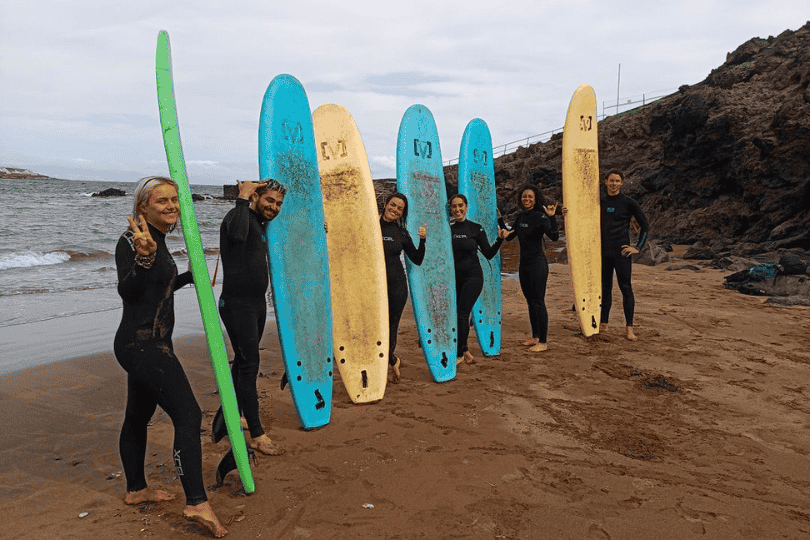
xmin=506 ymin=184 xmax=560 ymax=352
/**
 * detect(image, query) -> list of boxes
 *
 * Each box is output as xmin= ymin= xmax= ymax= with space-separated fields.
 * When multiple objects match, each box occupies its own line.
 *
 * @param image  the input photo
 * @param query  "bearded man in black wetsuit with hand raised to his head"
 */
xmin=213 ymin=180 xmax=287 ymax=456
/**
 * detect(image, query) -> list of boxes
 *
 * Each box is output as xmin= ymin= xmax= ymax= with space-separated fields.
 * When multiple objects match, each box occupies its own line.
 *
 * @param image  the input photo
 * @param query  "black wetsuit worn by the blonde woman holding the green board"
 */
xmin=114 ymin=225 xmax=207 ymax=505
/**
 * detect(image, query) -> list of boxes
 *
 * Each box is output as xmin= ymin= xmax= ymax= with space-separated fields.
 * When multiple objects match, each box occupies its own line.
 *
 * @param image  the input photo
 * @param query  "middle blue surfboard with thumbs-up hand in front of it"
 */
xmin=397 ymin=105 xmax=458 ymax=382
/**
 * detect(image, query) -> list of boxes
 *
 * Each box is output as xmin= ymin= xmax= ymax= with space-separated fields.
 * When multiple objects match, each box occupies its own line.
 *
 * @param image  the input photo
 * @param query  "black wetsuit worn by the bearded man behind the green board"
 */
xmin=219 ymin=199 xmax=270 ymax=438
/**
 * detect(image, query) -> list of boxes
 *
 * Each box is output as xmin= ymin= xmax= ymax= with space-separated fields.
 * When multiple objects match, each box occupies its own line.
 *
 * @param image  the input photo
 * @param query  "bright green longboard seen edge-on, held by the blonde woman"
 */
xmin=155 ymin=30 xmax=251 ymax=493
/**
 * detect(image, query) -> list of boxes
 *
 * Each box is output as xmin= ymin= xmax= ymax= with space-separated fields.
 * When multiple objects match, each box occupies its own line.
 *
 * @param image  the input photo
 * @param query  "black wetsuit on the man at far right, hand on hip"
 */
xmin=600 ymin=193 xmax=650 ymax=326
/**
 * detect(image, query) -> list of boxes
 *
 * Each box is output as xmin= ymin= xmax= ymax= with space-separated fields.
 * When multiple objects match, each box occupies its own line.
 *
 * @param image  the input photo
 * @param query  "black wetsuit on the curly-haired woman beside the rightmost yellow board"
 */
xmin=506 ymin=209 xmax=560 ymax=343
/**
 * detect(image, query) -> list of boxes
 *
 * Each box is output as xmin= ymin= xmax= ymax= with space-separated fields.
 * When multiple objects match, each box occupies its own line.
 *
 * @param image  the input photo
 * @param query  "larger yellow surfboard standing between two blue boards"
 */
xmin=312 ymin=103 xmax=389 ymax=403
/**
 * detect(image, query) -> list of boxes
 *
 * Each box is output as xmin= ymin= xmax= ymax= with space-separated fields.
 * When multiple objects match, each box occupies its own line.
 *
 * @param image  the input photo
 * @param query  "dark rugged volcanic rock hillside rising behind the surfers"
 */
xmin=445 ymin=22 xmax=810 ymax=255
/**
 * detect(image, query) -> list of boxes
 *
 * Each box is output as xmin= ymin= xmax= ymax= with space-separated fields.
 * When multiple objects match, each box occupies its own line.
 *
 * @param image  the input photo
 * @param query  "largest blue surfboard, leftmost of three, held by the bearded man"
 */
xmin=259 ymin=75 xmax=335 ymax=429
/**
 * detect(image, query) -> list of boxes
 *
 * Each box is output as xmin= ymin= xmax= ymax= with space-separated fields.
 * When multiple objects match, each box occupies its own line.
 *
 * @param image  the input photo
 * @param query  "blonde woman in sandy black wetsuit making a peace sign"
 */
xmin=114 ymin=177 xmax=228 ymax=538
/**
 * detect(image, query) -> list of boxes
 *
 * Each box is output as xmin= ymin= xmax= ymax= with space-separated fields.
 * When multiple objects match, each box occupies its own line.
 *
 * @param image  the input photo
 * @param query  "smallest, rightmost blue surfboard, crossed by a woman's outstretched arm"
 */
xmin=458 ymin=118 xmax=501 ymax=356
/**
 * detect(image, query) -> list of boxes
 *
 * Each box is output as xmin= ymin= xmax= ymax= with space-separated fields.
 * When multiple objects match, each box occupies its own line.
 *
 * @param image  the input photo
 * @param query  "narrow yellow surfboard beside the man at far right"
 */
xmin=562 ymin=85 xmax=602 ymax=337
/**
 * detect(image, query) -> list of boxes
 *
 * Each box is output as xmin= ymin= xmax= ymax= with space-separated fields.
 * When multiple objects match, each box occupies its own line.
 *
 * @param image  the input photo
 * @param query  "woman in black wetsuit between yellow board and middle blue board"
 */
xmin=380 ymin=193 xmax=427 ymax=383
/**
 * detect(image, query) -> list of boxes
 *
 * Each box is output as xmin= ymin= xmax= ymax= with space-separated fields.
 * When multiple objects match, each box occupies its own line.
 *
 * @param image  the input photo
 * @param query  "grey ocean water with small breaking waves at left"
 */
xmin=0 ymin=180 xmax=233 ymax=329
